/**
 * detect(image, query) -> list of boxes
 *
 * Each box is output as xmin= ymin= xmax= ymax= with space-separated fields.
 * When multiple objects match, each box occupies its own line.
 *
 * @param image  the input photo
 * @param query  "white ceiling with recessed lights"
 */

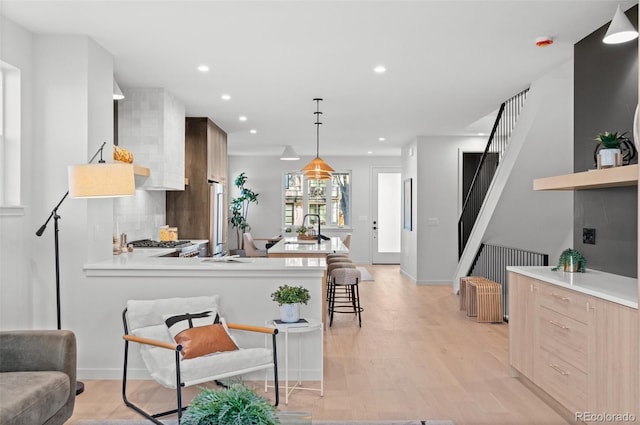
xmin=0 ymin=0 xmax=637 ymax=156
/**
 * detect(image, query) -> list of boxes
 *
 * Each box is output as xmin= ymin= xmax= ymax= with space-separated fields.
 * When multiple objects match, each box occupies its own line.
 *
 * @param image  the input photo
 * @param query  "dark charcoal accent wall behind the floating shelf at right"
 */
xmin=576 ymin=6 xmax=638 ymax=277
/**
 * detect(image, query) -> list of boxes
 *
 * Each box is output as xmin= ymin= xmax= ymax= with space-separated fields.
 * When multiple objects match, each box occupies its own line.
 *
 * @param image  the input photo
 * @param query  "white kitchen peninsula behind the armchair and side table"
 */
xmin=79 ymin=249 xmax=326 ymax=380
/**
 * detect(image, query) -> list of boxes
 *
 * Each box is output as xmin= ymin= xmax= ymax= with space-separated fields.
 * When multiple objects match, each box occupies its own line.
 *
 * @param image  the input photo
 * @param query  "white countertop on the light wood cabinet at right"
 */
xmin=507 ymin=266 xmax=638 ymax=309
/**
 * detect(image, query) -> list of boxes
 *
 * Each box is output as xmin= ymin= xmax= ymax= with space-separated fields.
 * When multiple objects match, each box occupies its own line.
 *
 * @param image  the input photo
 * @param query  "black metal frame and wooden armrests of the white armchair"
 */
xmin=122 ymin=308 xmax=280 ymax=425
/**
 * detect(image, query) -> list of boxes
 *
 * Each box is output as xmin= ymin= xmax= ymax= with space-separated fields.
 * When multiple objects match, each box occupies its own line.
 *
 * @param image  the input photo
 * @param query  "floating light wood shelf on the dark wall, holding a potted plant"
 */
xmin=533 ymin=164 xmax=638 ymax=190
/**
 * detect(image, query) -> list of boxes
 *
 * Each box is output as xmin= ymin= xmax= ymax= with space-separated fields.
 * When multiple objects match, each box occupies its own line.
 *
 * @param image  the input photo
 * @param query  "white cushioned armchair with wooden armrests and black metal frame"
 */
xmin=122 ymin=295 xmax=279 ymax=425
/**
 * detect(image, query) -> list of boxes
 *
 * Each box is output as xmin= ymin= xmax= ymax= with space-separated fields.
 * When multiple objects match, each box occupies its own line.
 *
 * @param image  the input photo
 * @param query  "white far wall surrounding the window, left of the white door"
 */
xmin=228 ymin=156 xmax=400 ymax=263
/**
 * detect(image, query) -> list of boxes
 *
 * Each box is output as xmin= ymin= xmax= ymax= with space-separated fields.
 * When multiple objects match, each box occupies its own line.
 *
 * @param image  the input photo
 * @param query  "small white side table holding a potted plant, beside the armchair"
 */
xmin=264 ymin=317 xmax=324 ymax=404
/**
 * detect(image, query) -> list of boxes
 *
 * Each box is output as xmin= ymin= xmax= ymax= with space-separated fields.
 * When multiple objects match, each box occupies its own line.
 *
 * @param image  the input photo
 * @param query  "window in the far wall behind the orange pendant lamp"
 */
xmin=283 ymin=172 xmax=351 ymax=227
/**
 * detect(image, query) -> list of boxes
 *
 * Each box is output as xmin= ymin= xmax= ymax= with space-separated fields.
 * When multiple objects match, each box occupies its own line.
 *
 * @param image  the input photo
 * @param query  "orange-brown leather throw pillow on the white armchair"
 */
xmin=175 ymin=324 xmax=238 ymax=359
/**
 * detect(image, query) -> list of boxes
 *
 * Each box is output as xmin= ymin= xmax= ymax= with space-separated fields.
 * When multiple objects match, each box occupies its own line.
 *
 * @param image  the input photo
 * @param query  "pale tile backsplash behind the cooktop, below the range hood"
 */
xmin=113 ymin=189 xmax=166 ymax=241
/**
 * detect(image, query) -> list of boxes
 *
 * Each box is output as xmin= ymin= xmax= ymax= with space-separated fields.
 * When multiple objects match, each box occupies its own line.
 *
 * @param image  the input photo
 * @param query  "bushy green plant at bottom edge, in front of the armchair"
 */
xmin=180 ymin=382 xmax=280 ymax=425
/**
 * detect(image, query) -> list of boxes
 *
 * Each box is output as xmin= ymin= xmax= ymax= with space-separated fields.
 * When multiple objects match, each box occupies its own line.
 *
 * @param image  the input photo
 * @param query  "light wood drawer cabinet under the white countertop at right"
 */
xmin=509 ymin=272 xmax=640 ymax=417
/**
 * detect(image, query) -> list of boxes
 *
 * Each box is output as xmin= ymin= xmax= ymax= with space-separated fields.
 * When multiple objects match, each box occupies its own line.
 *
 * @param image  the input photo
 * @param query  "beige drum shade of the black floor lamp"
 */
xmin=69 ymin=163 xmax=136 ymax=198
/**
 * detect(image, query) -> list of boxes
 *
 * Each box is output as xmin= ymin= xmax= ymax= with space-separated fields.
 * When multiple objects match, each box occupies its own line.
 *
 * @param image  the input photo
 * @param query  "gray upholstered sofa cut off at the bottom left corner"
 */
xmin=0 ymin=330 xmax=76 ymax=425
